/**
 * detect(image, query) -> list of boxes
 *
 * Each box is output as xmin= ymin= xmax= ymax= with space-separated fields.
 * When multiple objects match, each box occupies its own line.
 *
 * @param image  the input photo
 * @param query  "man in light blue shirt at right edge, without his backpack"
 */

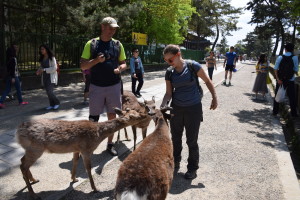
xmin=273 ymin=43 xmax=299 ymax=117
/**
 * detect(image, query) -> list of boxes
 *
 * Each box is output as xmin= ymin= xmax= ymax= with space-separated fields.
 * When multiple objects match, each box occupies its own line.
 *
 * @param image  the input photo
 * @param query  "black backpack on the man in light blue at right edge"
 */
xmin=277 ymin=55 xmax=295 ymax=81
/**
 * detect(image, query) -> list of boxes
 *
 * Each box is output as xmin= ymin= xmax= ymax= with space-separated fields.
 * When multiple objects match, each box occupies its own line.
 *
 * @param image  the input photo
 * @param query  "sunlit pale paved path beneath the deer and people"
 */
xmin=0 ymin=63 xmax=300 ymax=200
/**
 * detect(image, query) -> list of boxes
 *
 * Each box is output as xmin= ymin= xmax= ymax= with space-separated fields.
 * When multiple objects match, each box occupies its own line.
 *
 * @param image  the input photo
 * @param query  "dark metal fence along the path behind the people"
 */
xmin=0 ymin=32 xmax=204 ymax=73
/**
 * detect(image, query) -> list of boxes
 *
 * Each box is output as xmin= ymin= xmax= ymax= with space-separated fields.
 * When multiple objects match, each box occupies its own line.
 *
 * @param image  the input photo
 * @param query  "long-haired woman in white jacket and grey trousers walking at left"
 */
xmin=36 ymin=44 xmax=60 ymax=110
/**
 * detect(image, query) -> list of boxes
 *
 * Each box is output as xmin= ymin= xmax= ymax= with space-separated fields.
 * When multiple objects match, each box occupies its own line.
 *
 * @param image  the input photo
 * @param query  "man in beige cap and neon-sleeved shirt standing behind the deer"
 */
xmin=80 ymin=17 xmax=126 ymax=156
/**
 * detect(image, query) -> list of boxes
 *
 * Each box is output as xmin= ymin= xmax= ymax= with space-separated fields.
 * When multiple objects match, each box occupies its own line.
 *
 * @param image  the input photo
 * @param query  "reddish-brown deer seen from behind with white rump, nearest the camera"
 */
xmin=115 ymin=108 xmax=174 ymax=200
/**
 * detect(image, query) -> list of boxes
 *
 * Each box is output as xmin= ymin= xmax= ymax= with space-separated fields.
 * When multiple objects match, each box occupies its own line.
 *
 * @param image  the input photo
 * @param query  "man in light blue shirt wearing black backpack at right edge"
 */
xmin=273 ymin=43 xmax=299 ymax=117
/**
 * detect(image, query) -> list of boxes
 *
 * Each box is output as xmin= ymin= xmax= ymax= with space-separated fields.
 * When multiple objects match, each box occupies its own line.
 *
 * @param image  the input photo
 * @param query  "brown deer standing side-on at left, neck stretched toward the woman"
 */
xmin=16 ymin=108 xmax=145 ymax=199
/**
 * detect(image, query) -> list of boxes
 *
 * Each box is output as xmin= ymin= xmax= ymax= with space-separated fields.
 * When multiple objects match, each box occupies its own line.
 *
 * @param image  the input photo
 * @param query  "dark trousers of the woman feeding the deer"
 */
xmin=170 ymin=103 xmax=203 ymax=170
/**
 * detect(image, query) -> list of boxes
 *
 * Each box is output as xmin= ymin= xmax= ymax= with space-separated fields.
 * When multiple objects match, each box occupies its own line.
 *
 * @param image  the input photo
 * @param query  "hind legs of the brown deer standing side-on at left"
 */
xmin=20 ymin=149 xmax=43 ymax=199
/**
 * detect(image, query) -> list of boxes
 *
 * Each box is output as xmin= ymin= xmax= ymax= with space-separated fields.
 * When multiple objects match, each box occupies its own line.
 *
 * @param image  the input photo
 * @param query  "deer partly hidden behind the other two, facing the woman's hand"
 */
xmin=117 ymin=90 xmax=156 ymax=150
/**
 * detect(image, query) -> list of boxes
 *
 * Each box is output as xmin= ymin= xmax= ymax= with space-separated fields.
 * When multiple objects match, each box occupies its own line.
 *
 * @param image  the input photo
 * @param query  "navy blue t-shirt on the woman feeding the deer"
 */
xmin=165 ymin=61 xmax=202 ymax=106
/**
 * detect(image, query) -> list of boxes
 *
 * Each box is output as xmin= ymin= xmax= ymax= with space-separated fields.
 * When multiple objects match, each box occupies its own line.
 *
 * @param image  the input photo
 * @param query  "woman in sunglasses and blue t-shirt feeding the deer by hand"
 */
xmin=160 ymin=44 xmax=218 ymax=179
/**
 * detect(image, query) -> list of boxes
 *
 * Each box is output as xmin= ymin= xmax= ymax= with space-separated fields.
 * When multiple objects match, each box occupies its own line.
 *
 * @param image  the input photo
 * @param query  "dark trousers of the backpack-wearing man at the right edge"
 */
xmin=273 ymin=81 xmax=297 ymax=116
